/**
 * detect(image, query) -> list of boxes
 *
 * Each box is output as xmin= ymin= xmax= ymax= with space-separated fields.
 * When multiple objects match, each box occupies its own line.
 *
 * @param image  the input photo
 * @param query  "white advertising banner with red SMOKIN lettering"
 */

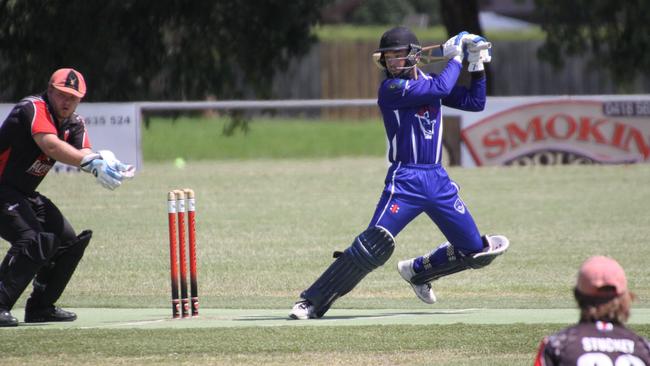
xmin=447 ymin=96 xmax=650 ymax=166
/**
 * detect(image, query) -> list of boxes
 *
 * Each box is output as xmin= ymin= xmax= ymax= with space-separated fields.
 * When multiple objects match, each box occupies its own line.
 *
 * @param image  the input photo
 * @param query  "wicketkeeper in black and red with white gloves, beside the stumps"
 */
xmin=0 ymin=69 xmax=135 ymax=326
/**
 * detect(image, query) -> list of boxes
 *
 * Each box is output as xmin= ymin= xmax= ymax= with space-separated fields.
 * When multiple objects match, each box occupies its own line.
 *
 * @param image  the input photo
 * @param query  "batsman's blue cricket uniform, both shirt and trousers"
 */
xmin=369 ymin=60 xmax=486 ymax=253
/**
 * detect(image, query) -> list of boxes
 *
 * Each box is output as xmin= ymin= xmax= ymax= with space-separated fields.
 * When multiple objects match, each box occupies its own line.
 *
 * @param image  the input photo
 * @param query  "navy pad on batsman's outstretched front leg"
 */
xmin=300 ymin=227 xmax=395 ymax=317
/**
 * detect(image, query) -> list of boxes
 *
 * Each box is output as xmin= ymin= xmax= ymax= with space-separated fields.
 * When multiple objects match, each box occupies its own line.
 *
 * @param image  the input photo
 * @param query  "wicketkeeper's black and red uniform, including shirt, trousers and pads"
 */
xmin=0 ymin=93 xmax=92 ymax=310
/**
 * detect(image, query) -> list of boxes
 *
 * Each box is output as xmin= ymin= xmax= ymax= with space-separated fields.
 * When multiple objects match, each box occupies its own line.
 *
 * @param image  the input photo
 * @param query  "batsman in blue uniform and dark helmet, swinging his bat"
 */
xmin=289 ymin=27 xmax=509 ymax=319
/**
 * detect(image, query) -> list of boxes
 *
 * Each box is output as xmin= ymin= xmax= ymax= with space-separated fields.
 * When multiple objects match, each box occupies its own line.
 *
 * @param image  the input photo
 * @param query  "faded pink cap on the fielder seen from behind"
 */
xmin=576 ymin=256 xmax=627 ymax=297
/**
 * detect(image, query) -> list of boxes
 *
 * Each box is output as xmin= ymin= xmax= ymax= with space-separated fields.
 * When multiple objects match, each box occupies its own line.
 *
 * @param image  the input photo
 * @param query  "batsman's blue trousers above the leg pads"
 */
xmin=368 ymin=163 xmax=483 ymax=254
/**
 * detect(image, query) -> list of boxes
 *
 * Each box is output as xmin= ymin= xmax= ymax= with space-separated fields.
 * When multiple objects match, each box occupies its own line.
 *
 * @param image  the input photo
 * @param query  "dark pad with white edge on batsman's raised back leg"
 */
xmin=411 ymin=235 xmax=510 ymax=285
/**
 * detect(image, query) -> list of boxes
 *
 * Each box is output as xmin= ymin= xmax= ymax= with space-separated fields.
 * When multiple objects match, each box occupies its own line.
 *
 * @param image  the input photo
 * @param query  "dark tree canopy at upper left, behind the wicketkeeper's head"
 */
xmin=0 ymin=0 xmax=327 ymax=101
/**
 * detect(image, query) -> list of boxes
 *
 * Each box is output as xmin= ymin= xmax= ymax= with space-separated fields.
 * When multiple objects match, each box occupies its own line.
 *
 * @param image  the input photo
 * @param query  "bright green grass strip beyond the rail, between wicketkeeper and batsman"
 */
xmin=142 ymin=117 xmax=386 ymax=161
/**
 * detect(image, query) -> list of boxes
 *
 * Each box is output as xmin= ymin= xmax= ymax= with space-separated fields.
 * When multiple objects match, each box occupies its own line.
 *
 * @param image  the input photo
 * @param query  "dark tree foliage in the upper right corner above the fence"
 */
xmin=535 ymin=0 xmax=650 ymax=84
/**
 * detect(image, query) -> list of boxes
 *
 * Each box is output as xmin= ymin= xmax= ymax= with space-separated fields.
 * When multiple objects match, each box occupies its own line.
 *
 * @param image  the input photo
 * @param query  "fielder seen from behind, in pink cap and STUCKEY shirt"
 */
xmin=535 ymin=256 xmax=650 ymax=366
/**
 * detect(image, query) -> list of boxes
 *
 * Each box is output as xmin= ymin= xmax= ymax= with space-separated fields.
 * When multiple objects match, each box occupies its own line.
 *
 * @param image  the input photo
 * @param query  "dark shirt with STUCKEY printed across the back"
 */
xmin=535 ymin=321 xmax=650 ymax=366
